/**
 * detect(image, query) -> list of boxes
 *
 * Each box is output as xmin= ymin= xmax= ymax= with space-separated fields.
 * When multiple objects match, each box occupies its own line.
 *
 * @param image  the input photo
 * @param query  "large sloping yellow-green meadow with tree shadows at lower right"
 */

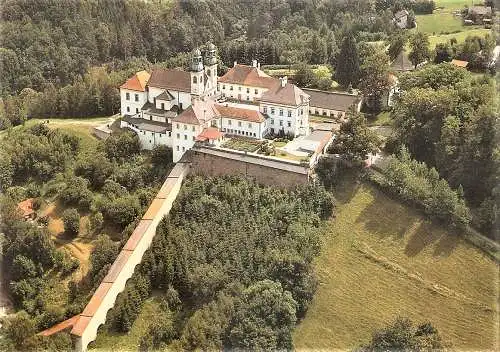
xmin=294 ymin=180 xmax=499 ymax=350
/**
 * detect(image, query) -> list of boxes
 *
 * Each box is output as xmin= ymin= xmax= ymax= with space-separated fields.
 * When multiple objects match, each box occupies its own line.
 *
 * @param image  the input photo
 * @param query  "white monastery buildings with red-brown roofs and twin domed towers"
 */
xmin=120 ymin=43 xmax=309 ymax=162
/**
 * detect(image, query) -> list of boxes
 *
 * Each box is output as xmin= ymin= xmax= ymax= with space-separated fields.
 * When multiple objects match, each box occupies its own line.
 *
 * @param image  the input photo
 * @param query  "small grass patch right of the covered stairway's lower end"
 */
xmin=89 ymin=297 xmax=167 ymax=352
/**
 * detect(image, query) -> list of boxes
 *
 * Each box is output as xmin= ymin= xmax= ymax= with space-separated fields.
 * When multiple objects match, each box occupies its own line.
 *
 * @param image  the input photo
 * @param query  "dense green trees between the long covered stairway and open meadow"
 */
xmin=87 ymin=177 xmax=334 ymax=350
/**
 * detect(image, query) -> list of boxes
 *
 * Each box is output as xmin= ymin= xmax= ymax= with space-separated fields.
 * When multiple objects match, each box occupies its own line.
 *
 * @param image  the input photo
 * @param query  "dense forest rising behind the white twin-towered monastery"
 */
xmin=0 ymin=0 xmax=476 ymax=130
